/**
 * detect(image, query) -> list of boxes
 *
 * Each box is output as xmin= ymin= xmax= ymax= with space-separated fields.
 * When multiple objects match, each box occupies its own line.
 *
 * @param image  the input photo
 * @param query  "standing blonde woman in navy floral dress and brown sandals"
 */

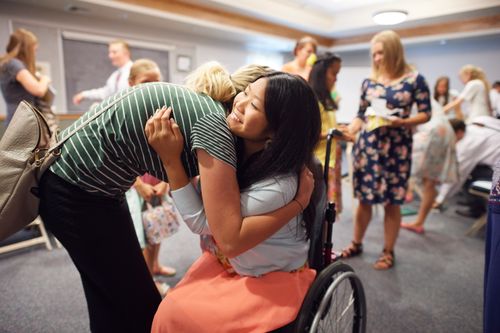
xmin=342 ymin=30 xmax=431 ymax=269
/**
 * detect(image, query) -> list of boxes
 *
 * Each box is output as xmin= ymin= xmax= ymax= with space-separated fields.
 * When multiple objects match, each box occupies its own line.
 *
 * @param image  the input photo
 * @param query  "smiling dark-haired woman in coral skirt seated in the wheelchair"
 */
xmin=147 ymin=72 xmax=321 ymax=332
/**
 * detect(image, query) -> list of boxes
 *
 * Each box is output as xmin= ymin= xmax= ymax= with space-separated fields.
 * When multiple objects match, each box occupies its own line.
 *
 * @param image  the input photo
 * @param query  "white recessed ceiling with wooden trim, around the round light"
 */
xmin=2 ymin=0 xmax=500 ymax=48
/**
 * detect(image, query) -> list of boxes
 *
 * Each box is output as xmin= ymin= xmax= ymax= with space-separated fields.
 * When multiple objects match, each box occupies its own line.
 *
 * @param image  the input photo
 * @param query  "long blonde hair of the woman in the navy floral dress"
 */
xmin=370 ymin=30 xmax=412 ymax=80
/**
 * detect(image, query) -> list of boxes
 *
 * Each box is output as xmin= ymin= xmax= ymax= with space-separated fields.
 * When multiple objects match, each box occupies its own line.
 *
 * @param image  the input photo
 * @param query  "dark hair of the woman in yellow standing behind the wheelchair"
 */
xmin=309 ymin=52 xmax=342 ymax=111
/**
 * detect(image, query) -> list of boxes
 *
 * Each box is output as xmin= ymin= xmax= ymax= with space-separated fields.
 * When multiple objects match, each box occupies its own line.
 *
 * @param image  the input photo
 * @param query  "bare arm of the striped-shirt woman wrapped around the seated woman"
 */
xmin=197 ymin=150 xmax=314 ymax=258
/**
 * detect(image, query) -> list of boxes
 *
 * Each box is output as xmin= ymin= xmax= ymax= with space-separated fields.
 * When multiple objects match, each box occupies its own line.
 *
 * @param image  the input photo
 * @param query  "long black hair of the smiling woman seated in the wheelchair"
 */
xmin=237 ymin=72 xmax=321 ymax=239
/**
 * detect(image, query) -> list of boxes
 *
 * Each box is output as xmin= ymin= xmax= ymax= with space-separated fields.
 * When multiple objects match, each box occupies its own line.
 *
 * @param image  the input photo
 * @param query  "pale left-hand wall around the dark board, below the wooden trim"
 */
xmin=0 ymin=2 xmax=281 ymax=114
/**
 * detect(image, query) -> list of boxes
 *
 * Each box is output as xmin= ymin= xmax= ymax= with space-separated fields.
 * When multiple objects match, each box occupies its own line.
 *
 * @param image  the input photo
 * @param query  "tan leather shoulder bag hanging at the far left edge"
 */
xmin=0 ymin=101 xmax=58 ymax=240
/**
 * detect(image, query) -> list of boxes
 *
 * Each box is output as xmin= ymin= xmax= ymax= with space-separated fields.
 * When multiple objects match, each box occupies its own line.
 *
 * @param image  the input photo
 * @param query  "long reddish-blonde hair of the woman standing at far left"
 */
xmin=0 ymin=28 xmax=38 ymax=75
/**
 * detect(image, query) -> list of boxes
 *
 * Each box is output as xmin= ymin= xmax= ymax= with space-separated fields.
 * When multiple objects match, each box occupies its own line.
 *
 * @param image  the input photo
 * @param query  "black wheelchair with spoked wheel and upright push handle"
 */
xmin=272 ymin=129 xmax=366 ymax=333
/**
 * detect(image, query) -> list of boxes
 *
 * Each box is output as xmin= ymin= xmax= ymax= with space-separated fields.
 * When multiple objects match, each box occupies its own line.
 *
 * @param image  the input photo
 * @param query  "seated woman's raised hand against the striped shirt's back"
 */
xmin=145 ymin=107 xmax=184 ymax=164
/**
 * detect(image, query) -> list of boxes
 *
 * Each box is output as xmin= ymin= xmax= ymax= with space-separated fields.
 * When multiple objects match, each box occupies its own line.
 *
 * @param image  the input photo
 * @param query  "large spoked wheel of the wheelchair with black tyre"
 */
xmin=294 ymin=261 xmax=366 ymax=333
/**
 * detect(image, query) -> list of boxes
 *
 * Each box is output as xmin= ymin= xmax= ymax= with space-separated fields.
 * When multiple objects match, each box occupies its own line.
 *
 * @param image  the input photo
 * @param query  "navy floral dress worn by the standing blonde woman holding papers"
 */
xmin=353 ymin=72 xmax=431 ymax=205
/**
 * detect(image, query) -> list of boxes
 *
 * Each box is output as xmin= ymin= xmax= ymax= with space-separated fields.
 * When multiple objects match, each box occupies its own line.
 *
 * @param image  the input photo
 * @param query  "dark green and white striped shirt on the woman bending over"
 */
xmin=50 ymin=82 xmax=236 ymax=197
